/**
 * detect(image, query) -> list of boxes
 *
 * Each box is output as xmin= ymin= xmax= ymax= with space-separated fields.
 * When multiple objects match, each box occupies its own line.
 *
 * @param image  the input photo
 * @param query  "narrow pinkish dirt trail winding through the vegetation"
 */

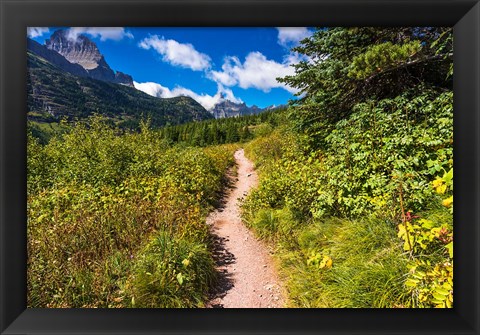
xmin=207 ymin=149 xmax=284 ymax=308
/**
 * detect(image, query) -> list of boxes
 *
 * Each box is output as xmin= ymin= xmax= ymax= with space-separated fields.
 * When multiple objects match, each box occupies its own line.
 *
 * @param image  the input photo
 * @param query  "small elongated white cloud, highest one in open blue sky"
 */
xmin=139 ymin=35 xmax=211 ymax=71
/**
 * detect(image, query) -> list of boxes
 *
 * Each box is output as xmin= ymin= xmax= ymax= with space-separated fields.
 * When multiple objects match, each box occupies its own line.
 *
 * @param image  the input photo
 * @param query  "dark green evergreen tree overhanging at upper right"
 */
xmin=278 ymin=27 xmax=453 ymax=149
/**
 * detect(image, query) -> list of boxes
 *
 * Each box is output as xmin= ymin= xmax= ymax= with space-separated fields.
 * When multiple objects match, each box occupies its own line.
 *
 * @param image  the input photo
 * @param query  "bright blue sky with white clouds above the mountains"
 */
xmin=27 ymin=27 xmax=313 ymax=109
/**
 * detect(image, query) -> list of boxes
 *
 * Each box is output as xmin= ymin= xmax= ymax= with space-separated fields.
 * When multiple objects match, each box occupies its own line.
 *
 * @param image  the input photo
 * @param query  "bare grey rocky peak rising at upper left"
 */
xmin=43 ymin=29 xmax=133 ymax=87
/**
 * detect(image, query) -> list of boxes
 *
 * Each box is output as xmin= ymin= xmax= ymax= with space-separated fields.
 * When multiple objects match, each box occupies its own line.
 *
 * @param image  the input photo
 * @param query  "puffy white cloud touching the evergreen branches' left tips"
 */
xmin=208 ymin=51 xmax=300 ymax=93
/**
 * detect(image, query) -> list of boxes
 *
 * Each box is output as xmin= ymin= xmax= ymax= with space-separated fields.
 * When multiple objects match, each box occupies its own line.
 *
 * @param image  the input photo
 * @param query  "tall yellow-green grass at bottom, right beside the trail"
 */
xmin=282 ymin=218 xmax=408 ymax=308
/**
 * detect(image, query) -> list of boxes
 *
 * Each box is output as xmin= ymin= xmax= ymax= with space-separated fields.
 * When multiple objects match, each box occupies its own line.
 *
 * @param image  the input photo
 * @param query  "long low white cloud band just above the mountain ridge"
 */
xmin=133 ymin=81 xmax=242 ymax=110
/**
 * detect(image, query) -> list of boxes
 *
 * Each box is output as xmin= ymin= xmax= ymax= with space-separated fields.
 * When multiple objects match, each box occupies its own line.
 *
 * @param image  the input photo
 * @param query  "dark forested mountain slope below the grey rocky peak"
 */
xmin=27 ymin=50 xmax=213 ymax=129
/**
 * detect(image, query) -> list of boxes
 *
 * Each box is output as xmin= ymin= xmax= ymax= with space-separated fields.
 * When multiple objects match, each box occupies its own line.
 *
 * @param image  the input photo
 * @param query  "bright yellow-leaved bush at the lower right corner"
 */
xmin=398 ymin=169 xmax=453 ymax=308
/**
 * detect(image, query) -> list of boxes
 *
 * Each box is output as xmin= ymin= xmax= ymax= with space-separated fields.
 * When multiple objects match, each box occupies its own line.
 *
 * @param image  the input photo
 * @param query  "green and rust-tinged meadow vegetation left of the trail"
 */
xmin=27 ymin=118 xmax=236 ymax=307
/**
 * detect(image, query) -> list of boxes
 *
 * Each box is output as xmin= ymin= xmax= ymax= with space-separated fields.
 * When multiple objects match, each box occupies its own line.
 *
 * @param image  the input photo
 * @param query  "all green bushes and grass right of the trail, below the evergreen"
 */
xmin=242 ymin=90 xmax=453 ymax=307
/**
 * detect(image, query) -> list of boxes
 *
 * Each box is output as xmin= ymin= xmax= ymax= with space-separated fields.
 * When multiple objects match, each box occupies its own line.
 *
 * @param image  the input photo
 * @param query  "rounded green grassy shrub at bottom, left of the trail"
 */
xmin=131 ymin=231 xmax=216 ymax=308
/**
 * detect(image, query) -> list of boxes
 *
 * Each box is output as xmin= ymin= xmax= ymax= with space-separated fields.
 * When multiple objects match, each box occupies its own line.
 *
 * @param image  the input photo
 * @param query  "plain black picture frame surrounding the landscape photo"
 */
xmin=0 ymin=0 xmax=480 ymax=334
